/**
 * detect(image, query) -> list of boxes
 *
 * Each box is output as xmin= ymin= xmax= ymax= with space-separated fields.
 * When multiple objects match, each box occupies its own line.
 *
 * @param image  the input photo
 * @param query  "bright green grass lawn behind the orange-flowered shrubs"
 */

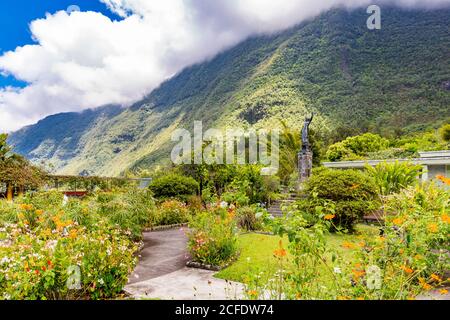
xmin=215 ymin=225 xmax=379 ymax=283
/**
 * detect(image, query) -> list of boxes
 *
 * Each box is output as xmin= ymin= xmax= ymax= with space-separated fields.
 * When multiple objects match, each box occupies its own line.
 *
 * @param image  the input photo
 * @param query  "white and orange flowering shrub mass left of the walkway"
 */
xmin=0 ymin=204 xmax=137 ymax=299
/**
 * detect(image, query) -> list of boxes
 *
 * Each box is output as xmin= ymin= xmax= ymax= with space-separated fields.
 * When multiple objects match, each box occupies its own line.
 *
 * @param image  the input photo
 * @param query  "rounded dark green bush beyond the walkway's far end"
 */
xmin=149 ymin=174 xmax=199 ymax=200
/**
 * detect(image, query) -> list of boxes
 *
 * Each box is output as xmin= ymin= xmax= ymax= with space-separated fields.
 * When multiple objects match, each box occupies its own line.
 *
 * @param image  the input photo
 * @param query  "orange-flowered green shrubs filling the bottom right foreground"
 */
xmin=247 ymin=184 xmax=450 ymax=300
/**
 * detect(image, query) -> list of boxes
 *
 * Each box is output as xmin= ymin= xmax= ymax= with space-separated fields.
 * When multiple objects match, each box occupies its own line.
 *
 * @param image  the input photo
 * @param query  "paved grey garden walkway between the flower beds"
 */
xmin=125 ymin=229 xmax=244 ymax=300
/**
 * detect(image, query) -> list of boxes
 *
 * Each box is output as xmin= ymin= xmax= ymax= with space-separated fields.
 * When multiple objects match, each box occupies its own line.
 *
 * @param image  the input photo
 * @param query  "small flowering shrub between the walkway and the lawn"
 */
xmin=188 ymin=209 xmax=238 ymax=266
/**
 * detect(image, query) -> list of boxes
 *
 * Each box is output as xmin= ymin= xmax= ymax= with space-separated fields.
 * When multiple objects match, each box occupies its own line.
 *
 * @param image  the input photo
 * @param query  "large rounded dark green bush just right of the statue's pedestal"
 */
xmin=299 ymin=168 xmax=379 ymax=230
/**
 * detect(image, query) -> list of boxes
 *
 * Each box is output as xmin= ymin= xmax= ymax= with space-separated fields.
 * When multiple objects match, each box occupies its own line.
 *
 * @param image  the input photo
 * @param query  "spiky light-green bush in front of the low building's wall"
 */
xmin=366 ymin=161 xmax=422 ymax=195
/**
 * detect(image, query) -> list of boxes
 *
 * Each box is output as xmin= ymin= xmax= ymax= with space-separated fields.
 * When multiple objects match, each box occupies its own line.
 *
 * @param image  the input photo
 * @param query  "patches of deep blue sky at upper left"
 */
xmin=0 ymin=0 xmax=120 ymax=87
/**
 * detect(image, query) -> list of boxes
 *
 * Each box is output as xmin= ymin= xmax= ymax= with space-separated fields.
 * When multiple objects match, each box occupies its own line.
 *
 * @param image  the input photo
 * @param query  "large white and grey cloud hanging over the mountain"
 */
xmin=0 ymin=0 xmax=450 ymax=131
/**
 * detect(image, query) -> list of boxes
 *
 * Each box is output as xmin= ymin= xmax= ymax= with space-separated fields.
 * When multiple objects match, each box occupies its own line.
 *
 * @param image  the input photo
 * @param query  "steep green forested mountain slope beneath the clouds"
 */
xmin=6 ymin=9 xmax=450 ymax=175
